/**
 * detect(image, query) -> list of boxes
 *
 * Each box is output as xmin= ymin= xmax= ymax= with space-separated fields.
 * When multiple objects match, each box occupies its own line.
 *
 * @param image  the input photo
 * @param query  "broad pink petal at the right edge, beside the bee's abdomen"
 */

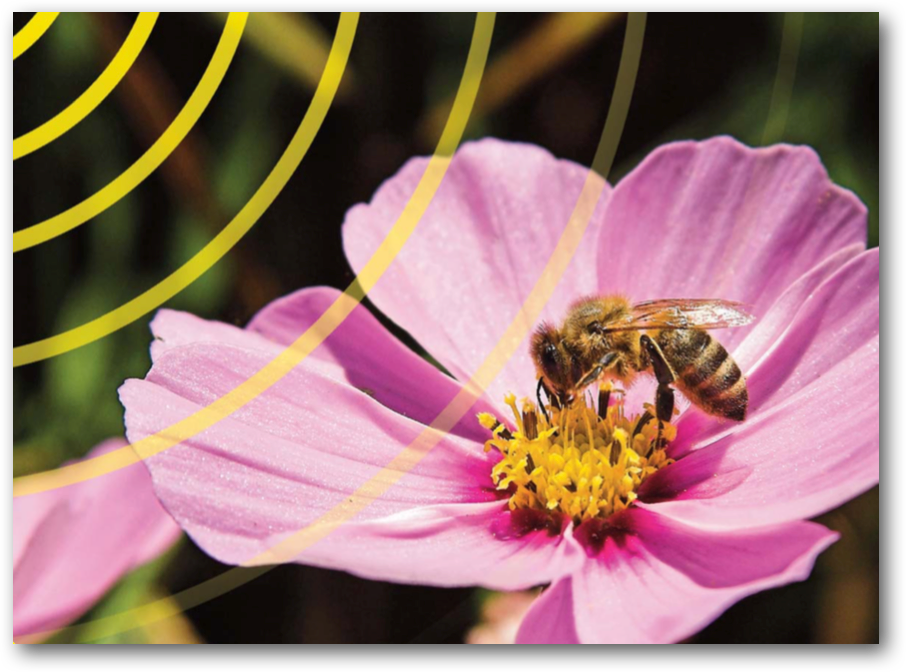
xmin=644 ymin=250 xmax=880 ymax=527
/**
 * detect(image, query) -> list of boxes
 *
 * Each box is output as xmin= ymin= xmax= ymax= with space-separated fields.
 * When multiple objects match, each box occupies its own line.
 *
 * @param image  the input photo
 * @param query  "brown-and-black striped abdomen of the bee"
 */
xmin=650 ymin=329 xmax=749 ymax=422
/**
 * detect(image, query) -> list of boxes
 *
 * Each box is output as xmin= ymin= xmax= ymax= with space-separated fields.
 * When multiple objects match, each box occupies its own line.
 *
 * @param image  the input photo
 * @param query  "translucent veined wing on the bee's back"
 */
xmin=607 ymin=299 xmax=755 ymax=331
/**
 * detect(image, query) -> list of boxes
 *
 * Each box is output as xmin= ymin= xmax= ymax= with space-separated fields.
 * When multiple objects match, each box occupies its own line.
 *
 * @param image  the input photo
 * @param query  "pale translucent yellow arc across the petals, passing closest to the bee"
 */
xmin=17 ymin=12 xmax=647 ymax=639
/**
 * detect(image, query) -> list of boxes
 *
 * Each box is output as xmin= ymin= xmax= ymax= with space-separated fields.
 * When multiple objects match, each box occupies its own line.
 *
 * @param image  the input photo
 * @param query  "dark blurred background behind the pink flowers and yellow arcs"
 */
xmin=12 ymin=12 xmax=879 ymax=644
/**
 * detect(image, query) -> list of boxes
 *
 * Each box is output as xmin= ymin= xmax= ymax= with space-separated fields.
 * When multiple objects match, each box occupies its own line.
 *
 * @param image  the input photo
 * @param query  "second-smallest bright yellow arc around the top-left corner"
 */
xmin=13 ymin=12 xmax=160 ymax=161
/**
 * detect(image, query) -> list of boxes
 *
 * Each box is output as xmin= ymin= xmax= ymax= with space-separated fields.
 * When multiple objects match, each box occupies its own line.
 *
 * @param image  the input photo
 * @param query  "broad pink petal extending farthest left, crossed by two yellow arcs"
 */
xmin=121 ymin=345 xmax=556 ymax=585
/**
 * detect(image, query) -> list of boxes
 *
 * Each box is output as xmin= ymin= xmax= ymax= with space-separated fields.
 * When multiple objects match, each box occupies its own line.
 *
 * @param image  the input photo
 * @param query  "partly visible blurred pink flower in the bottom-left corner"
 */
xmin=13 ymin=440 xmax=180 ymax=640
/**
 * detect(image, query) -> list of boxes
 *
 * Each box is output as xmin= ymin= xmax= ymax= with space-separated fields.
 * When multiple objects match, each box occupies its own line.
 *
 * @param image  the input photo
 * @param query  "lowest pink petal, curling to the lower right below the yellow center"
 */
xmin=520 ymin=510 xmax=838 ymax=644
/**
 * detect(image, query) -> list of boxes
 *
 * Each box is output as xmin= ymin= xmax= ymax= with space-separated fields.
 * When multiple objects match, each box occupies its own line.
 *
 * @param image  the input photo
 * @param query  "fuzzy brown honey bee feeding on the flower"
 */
xmin=531 ymin=296 xmax=755 ymax=423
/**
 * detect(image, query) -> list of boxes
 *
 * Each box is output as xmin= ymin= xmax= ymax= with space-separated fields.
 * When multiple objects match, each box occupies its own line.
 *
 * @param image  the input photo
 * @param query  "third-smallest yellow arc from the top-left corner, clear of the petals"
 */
xmin=13 ymin=12 xmax=249 ymax=255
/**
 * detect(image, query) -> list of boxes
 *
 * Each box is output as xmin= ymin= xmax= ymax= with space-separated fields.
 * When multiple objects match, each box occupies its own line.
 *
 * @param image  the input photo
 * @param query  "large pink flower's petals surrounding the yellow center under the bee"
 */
xmin=121 ymin=138 xmax=880 ymax=643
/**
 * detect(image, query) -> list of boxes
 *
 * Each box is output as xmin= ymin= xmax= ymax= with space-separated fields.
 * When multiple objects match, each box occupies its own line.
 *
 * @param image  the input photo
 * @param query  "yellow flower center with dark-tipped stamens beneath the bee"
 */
xmin=478 ymin=391 xmax=676 ymax=525
